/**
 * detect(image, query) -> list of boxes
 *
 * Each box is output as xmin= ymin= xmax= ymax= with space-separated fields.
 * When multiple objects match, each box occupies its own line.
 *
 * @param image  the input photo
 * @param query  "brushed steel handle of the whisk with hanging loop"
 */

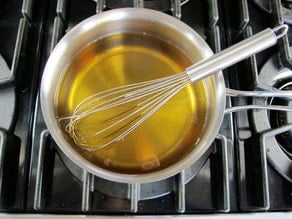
xmin=186 ymin=24 xmax=288 ymax=82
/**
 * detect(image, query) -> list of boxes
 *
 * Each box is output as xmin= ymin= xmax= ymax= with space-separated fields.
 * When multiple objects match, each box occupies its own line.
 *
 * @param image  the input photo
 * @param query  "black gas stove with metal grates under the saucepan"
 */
xmin=0 ymin=0 xmax=292 ymax=218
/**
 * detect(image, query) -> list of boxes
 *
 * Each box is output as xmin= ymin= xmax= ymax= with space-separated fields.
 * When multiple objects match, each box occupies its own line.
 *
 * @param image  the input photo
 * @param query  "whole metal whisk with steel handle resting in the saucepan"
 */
xmin=59 ymin=25 xmax=288 ymax=150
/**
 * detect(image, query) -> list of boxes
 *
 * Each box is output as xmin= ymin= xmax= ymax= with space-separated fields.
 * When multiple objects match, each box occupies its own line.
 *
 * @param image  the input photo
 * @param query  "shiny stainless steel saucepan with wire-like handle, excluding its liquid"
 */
xmin=40 ymin=8 xmax=291 ymax=183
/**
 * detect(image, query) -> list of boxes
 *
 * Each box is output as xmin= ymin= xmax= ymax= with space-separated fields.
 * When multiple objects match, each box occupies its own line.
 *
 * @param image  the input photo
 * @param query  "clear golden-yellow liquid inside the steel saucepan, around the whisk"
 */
xmin=57 ymin=33 xmax=208 ymax=174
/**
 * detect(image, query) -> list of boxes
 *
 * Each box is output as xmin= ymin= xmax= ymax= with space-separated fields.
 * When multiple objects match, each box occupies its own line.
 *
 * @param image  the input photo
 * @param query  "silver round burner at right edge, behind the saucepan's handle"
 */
xmin=252 ymin=48 xmax=292 ymax=182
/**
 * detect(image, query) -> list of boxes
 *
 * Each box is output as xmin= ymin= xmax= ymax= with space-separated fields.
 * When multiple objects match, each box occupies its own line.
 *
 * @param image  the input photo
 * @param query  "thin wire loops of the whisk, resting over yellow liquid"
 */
xmin=59 ymin=73 xmax=190 ymax=150
